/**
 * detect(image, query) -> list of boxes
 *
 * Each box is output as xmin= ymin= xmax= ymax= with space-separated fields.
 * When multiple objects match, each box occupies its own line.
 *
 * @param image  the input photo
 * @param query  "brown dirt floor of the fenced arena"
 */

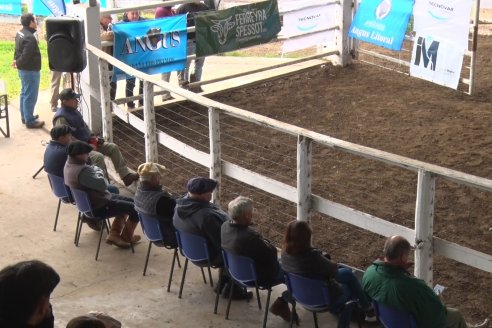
xmin=115 ymin=36 xmax=492 ymax=322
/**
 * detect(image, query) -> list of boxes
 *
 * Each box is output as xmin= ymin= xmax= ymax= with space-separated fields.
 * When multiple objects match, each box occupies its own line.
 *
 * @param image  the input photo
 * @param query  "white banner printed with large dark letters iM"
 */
xmin=410 ymin=34 xmax=464 ymax=89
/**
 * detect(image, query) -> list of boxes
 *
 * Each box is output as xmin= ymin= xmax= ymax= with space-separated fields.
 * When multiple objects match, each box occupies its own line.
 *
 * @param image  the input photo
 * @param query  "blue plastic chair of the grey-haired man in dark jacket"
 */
xmin=219 ymin=249 xmax=280 ymax=328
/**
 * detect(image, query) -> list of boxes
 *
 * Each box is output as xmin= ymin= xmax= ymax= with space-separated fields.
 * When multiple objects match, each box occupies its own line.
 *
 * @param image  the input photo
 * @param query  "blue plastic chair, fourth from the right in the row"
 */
xmin=176 ymin=229 xmax=214 ymax=298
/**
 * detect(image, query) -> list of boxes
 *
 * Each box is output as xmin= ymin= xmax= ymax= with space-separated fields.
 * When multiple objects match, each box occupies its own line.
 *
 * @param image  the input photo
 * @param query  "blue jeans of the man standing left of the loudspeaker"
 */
xmin=18 ymin=69 xmax=41 ymax=124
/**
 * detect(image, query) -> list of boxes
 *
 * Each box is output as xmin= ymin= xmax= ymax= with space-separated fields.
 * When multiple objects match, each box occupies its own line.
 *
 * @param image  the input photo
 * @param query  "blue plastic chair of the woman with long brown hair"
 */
xmin=285 ymin=272 xmax=361 ymax=328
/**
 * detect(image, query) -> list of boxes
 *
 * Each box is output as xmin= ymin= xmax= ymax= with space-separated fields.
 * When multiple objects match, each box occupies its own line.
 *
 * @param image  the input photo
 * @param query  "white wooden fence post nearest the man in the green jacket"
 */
xmin=414 ymin=169 xmax=436 ymax=287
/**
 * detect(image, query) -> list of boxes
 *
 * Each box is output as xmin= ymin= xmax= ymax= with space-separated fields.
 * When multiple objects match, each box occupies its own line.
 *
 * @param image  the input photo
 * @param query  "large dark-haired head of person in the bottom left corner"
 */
xmin=0 ymin=260 xmax=60 ymax=328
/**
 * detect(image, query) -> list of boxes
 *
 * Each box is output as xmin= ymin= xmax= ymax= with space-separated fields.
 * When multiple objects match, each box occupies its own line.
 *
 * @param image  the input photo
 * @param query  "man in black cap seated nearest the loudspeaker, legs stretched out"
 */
xmin=53 ymin=88 xmax=138 ymax=186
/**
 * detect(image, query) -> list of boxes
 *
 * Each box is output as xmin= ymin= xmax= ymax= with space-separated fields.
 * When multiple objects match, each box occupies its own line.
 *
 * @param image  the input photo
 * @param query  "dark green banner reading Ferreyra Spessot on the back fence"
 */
xmin=195 ymin=0 xmax=280 ymax=57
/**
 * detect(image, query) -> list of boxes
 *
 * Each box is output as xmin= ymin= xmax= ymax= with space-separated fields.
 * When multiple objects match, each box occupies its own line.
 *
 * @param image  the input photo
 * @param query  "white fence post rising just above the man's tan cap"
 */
xmin=143 ymin=81 xmax=159 ymax=163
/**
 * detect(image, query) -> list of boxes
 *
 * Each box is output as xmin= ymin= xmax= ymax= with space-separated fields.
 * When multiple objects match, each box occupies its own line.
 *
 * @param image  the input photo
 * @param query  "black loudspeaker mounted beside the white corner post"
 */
xmin=45 ymin=17 xmax=87 ymax=73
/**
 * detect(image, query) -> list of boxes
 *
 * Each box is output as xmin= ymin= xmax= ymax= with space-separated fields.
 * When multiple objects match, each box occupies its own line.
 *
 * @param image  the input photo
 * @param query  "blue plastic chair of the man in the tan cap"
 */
xmin=137 ymin=212 xmax=181 ymax=292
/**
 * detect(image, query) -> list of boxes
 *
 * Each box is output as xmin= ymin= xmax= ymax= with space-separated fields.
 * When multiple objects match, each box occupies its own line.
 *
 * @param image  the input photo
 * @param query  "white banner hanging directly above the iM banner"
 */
xmin=414 ymin=0 xmax=472 ymax=49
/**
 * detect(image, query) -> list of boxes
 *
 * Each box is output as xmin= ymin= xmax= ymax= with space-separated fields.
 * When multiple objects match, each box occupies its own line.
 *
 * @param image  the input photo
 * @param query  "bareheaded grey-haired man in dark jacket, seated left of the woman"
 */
xmin=221 ymin=196 xmax=299 ymax=322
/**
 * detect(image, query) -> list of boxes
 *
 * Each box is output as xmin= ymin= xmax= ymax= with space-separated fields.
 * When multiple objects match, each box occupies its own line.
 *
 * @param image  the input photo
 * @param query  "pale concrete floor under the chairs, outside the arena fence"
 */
xmin=0 ymin=57 xmax=364 ymax=328
